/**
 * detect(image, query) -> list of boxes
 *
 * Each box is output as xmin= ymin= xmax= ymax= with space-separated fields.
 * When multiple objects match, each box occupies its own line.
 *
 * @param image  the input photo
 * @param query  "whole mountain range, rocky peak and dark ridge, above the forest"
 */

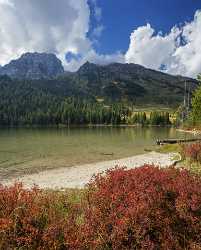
xmin=0 ymin=53 xmax=197 ymax=106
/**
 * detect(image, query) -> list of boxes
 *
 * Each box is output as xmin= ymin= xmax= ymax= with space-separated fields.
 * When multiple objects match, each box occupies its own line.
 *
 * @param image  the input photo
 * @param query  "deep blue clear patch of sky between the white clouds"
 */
xmin=91 ymin=0 xmax=201 ymax=54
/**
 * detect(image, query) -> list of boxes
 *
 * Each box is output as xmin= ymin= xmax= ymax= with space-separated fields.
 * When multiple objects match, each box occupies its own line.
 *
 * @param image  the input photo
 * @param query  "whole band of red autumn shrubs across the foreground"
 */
xmin=0 ymin=165 xmax=201 ymax=250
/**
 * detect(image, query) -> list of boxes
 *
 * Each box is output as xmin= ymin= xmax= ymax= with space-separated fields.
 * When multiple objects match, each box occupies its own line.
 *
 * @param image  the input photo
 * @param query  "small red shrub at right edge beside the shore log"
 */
xmin=182 ymin=143 xmax=201 ymax=163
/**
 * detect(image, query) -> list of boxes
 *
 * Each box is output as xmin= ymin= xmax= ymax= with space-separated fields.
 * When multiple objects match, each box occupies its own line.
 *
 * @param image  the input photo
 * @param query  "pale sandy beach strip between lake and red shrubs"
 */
xmin=2 ymin=152 xmax=177 ymax=189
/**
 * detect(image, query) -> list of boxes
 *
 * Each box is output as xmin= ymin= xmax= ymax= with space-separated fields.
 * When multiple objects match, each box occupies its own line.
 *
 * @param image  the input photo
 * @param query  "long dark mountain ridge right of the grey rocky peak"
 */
xmin=71 ymin=62 xmax=197 ymax=105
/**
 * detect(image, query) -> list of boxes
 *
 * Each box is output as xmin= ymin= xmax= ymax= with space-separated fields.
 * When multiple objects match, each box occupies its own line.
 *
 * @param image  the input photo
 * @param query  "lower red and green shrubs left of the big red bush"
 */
xmin=0 ymin=184 xmax=83 ymax=250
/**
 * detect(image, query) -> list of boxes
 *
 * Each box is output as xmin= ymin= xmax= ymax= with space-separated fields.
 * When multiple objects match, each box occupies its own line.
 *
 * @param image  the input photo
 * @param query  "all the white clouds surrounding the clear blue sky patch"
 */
xmin=0 ymin=0 xmax=201 ymax=77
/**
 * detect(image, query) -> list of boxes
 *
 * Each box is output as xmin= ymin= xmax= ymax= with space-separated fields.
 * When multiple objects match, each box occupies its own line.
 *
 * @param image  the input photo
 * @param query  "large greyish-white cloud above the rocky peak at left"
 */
xmin=0 ymin=0 xmax=91 ymax=67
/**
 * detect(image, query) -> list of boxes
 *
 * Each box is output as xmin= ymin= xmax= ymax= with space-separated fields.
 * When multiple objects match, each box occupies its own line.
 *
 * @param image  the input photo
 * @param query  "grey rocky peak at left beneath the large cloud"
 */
xmin=0 ymin=53 xmax=64 ymax=79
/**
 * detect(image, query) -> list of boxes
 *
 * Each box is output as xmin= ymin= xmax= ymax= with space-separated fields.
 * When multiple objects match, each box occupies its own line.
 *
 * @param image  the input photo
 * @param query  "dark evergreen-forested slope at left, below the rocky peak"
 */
xmin=0 ymin=77 xmax=129 ymax=125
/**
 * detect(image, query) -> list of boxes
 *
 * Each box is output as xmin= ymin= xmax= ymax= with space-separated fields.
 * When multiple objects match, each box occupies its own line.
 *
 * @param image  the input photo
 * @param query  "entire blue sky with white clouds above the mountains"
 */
xmin=0 ymin=0 xmax=201 ymax=77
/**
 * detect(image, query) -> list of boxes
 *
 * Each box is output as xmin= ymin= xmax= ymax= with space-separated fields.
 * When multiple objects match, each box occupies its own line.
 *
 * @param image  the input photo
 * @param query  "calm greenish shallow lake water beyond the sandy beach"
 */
xmin=0 ymin=127 xmax=193 ymax=180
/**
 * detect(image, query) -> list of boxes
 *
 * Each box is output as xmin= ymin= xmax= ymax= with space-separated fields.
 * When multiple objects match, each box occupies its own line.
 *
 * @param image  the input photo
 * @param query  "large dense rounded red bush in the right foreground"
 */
xmin=85 ymin=165 xmax=201 ymax=250
